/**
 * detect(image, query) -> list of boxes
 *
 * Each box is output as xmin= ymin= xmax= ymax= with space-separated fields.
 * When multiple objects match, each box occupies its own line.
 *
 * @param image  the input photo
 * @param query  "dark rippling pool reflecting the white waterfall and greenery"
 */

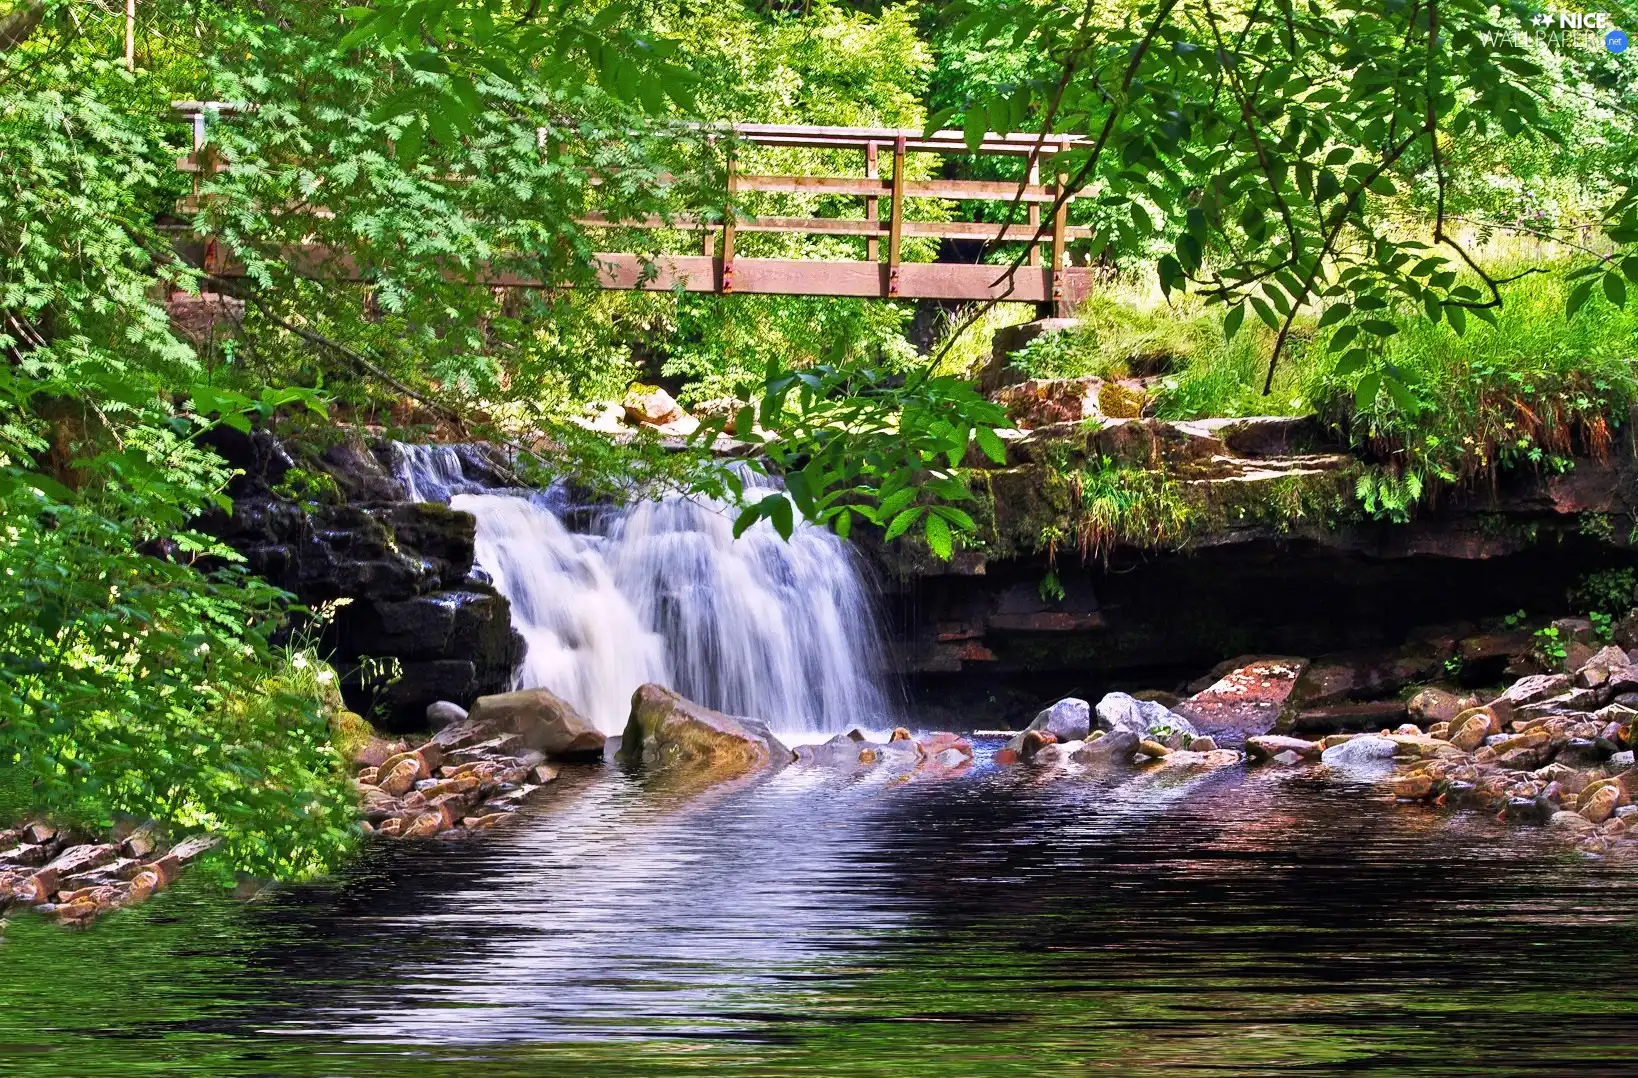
xmin=0 ymin=740 xmax=1638 ymax=1078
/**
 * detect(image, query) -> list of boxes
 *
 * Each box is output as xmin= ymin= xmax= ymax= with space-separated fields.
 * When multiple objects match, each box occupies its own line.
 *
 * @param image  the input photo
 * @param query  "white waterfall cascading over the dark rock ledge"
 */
xmin=396 ymin=446 xmax=891 ymax=734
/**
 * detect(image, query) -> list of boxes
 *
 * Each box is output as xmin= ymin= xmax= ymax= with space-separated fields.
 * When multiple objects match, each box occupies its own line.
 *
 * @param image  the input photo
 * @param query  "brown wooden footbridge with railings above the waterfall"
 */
xmin=175 ymin=102 xmax=1093 ymax=315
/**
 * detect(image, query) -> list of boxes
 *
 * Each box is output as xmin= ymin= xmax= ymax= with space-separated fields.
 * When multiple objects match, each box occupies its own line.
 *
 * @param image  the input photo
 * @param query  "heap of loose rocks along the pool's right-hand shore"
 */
xmin=976 ymin=645 xmax=1638 ymax=858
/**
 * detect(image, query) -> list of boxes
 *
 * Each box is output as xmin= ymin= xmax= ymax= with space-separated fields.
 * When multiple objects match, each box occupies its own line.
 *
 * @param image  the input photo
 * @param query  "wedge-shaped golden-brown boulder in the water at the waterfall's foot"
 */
xmin=619 ymin=685 xmax=793 ymax=778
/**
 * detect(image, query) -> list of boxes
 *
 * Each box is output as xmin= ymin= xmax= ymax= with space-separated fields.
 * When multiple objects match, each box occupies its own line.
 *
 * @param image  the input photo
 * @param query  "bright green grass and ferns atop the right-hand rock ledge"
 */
xmin=1017 ymin=245 xmax=1638 ymax=490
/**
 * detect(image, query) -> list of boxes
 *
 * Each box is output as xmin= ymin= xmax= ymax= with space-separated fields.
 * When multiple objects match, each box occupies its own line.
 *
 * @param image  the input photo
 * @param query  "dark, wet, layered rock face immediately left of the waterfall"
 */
xmin=198 ymin=428 xmax=523 ymax=731
